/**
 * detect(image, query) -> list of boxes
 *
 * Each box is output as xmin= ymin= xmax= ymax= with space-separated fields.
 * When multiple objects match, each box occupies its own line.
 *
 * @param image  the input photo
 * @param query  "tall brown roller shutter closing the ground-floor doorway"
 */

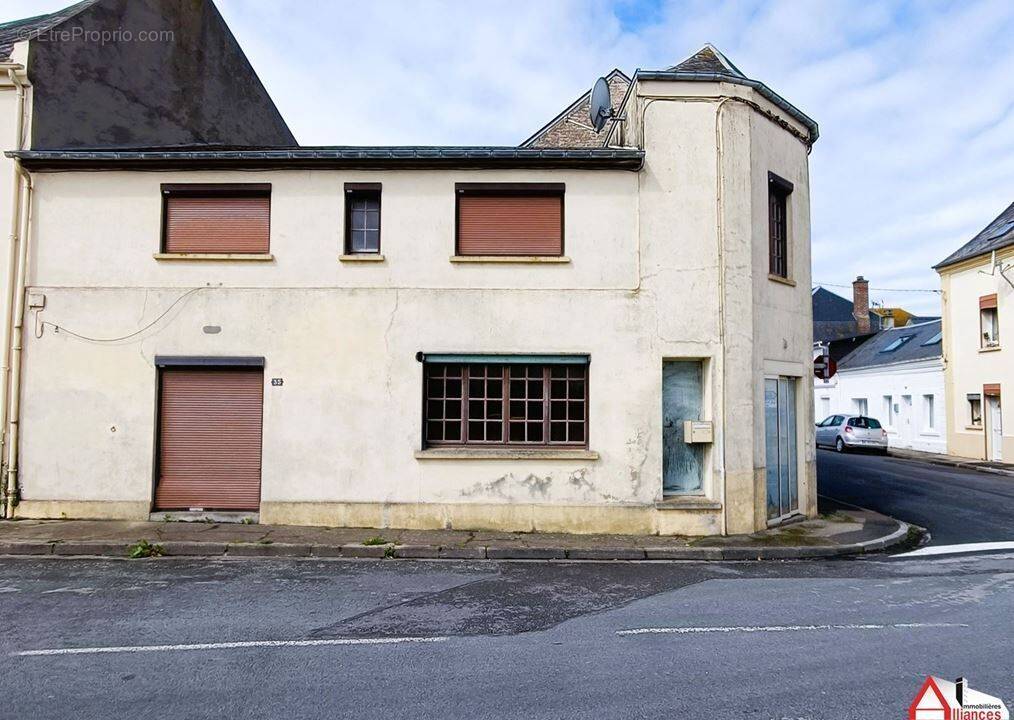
xmin=155 ymin=368 xmax=264 ymax=510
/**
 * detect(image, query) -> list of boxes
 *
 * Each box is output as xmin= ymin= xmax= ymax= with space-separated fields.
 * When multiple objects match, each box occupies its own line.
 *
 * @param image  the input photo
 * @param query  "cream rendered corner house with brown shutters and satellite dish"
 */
xmin=3 ymin=42 xmax=817 ymax=534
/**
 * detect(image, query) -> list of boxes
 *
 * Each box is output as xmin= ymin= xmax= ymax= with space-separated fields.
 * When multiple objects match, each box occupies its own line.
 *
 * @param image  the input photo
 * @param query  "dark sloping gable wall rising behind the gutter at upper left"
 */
xmin=28 ymin=0 xmax=296 ymax=148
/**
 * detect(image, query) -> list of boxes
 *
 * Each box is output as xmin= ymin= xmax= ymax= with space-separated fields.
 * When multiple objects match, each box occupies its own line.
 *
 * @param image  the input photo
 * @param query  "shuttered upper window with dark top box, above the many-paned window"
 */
xmin=454 ymin=183 xmax=565 ymax=257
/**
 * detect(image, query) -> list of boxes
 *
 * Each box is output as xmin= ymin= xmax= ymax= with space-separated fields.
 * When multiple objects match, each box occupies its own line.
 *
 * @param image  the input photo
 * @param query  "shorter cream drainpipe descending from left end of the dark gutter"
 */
xmin=4 ymin=163 xmax=32 ymax=518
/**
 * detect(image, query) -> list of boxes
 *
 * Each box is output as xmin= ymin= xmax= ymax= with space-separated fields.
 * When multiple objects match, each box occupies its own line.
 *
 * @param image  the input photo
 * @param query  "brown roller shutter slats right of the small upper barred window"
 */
xmin=457 ymin=194 xmax=564 ymax=256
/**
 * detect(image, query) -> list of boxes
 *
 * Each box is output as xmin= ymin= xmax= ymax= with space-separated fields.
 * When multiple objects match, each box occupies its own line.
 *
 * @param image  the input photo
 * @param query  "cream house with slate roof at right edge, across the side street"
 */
xmin=936 ymin=204 xmax=1014 ymax=462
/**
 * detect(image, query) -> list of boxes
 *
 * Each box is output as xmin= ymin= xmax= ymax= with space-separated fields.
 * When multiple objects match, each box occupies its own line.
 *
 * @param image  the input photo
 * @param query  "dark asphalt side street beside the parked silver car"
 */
xmin=817 ymin=450 xmax=1014 ymax=545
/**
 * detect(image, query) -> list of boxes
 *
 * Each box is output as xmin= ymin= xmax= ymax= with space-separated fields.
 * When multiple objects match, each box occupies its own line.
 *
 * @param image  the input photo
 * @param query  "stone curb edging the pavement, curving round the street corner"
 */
xmin=0 ymin=520 xmax=914 ymax=562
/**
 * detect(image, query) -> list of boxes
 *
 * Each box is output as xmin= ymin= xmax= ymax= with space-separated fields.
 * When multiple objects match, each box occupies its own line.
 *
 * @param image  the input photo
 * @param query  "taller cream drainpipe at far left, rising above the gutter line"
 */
xmin=0 ymin=65 xmax=25 ymax=517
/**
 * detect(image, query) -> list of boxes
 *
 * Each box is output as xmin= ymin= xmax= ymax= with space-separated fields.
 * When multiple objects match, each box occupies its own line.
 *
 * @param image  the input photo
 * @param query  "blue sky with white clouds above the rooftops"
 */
xmin=7 ymin=0 xmax=1014 ymax=313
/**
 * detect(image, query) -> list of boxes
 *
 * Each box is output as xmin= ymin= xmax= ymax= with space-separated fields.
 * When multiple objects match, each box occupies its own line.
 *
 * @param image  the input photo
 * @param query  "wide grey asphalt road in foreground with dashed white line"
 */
xmin=0 ymin=554 xmax=1014 ymax=720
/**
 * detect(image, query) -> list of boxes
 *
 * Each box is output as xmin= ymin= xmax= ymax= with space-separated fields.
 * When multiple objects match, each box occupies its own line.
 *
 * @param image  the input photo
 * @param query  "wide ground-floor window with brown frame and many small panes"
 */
xmin=423 ymin=362 xmax=588 ymax=447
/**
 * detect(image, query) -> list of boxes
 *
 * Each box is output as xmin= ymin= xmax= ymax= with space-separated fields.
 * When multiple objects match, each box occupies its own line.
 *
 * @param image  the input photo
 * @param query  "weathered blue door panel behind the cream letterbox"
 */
xmin=662 ymin=360 xmax=704 ymax=495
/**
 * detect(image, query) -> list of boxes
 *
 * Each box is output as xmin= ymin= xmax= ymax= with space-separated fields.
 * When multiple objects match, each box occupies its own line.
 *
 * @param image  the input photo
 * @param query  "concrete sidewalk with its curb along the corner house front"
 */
xmin=0 ymin=508 xmax=918 ymax=560
